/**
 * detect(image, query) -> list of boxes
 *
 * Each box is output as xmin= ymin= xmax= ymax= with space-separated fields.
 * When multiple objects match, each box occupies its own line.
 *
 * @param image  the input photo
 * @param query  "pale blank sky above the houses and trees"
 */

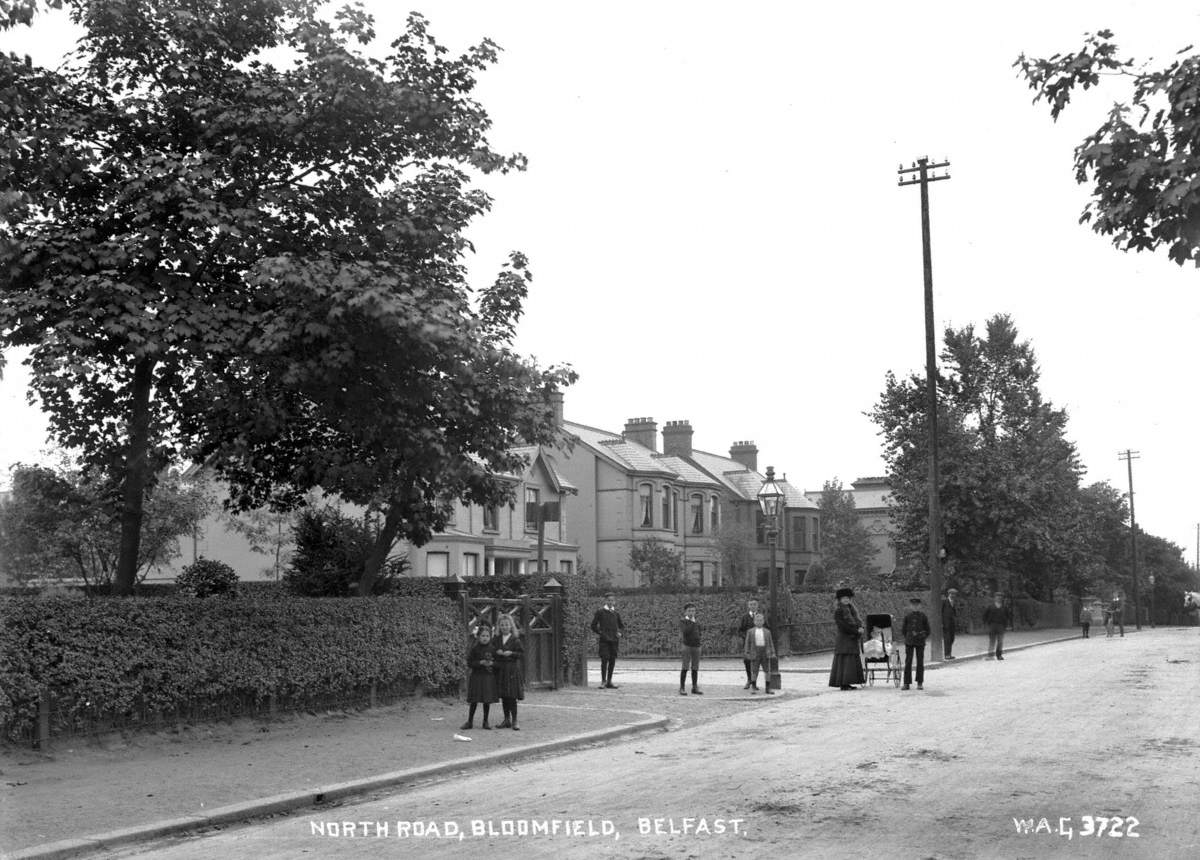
xmin=0 ymin=0 xmax=1200 ymax=564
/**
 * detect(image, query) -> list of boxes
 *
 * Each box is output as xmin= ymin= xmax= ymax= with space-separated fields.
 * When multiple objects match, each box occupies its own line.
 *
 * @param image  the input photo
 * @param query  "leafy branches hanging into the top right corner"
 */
xmin=1014 ymin=30 xmax=1200 ymax=266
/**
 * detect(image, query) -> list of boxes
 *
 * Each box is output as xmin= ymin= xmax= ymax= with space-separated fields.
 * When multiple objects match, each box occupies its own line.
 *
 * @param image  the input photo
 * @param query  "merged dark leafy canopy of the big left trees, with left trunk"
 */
xmin=0 ymin=0 xmax=571 ymax=591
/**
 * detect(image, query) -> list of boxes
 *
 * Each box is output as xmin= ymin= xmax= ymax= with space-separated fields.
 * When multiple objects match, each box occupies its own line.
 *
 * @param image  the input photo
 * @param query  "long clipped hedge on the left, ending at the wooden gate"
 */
xmin=0 ymin=596 xmax=466 ymax=738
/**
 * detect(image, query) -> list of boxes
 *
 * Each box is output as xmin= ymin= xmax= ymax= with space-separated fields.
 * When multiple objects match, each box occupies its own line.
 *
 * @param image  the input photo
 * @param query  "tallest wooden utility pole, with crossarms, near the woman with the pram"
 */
xmin=898 ymin=157 xmax=950 ymax=660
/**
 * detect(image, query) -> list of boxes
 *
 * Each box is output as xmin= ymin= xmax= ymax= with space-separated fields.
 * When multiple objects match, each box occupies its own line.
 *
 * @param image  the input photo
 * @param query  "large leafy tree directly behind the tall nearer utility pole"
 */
xmin=872 ymin=314 xmax=1080 ymax=594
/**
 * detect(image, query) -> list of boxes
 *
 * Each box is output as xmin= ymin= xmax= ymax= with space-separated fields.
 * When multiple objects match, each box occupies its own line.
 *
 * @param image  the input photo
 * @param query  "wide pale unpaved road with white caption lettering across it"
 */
xmin=114 ymin=627 xmax=1200 ymax=860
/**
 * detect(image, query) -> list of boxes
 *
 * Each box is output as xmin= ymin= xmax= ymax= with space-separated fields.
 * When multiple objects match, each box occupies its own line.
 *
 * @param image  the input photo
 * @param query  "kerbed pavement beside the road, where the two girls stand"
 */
xmin=0 ymin=629 xmax=1089 ymax=860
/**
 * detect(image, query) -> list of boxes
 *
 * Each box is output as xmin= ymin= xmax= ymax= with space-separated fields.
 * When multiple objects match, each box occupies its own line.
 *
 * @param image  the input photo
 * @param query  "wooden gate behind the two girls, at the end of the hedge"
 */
xmin=462 ymin=595 xmax=563 ymax=690
